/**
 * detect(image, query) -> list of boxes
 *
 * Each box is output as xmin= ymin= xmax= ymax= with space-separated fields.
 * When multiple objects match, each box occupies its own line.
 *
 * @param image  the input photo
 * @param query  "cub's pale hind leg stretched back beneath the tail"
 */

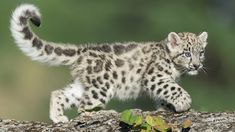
xmin=50 ymin=83 xmax=84 ymax=123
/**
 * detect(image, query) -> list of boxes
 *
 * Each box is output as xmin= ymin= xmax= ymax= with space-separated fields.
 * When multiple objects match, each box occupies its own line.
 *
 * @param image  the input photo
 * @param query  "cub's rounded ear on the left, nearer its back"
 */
xmin=167 ymin=32 xmax=181 ymax=51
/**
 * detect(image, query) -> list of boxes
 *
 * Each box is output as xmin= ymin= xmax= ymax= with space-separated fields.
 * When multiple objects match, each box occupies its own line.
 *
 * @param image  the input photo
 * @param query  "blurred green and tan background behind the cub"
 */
xmin=0 ymin=0 xmax=235 ymax=122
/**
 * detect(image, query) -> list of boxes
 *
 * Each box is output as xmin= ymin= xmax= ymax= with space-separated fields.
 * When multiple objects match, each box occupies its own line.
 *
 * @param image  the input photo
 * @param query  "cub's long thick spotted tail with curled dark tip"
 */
xmin=10 ymin=4 xmax=80 ymax=65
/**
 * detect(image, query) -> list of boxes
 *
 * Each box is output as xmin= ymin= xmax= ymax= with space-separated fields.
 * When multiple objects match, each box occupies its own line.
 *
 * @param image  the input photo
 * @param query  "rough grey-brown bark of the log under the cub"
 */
xmin=0 ymin=109 xmax=235 ymax=132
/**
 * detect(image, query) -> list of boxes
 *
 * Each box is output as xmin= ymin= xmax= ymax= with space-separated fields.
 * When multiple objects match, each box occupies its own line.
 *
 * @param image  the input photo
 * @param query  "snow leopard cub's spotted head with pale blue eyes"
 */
xmin=167 ymin=32 xmax=208 ymax=75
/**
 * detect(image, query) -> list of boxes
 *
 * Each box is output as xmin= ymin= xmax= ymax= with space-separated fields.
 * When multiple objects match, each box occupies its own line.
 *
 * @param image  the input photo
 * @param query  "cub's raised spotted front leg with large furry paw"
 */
xmin=145 ymin=77 xmax=192 ymax=112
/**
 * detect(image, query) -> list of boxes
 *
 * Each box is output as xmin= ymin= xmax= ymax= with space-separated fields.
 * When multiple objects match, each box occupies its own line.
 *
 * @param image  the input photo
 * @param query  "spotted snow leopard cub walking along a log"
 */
xmin=10 ymin=4 xmax=207 ymax=122
